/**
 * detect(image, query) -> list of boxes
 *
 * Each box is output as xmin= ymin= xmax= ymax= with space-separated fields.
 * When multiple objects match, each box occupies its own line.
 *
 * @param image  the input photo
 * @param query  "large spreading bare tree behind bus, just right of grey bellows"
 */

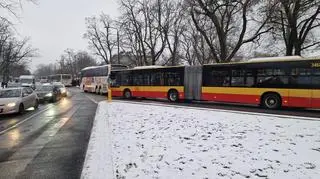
xmin=187 ymin=0 xmax=272 ymax=63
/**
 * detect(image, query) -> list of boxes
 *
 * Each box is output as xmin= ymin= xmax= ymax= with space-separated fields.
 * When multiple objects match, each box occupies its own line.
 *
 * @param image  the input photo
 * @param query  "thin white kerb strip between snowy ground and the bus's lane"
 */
xmin=114 ymin=100 xmax=320 ymax=121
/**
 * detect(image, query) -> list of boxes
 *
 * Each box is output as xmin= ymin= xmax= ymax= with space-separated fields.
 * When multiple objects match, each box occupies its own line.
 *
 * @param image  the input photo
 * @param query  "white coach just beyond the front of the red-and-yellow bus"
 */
xmin=80 ymin=65 xmax=111 ymax=94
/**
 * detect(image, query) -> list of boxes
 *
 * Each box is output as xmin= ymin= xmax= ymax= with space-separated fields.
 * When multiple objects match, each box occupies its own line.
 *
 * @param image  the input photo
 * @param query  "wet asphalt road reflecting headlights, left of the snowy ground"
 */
xmin=0 ymin=88 xmax=97 ymax=179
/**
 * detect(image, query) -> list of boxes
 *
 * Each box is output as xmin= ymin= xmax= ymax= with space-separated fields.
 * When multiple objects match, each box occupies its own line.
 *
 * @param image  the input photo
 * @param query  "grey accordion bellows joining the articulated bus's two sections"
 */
xmin=184 ymin=66 xmax=202 ymax=100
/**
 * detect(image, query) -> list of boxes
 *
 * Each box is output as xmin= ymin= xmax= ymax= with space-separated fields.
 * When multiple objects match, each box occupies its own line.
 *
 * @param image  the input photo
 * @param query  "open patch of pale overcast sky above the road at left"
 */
xmin=16 ymin=0 xmax=119 ymax=71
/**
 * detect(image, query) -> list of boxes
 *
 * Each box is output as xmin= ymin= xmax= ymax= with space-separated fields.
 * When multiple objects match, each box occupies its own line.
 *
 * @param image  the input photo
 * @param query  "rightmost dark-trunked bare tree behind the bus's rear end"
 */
xmin=270 ymin=0 xmax=320 ymax=56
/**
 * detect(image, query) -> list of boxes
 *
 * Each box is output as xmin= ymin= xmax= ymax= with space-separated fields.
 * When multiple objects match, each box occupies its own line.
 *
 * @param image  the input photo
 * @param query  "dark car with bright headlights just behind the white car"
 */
xmin=36 ymin=85 xmax=62 ymax=102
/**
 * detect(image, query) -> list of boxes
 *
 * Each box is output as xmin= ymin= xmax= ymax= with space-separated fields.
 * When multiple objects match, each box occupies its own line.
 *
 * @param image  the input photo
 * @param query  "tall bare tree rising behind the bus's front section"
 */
xmin=121 ymin=0 xmax=170 ymax=65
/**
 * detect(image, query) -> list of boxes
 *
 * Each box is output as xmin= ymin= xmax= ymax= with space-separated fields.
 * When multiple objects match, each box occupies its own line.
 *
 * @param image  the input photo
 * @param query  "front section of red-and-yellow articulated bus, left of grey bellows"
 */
xmin=111 ymin=66 xmax=185 ymax=101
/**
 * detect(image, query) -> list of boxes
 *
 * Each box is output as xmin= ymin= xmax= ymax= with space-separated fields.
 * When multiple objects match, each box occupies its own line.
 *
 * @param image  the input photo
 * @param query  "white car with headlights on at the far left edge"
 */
xmin=0 ymin=87 xmax=39 ymax=114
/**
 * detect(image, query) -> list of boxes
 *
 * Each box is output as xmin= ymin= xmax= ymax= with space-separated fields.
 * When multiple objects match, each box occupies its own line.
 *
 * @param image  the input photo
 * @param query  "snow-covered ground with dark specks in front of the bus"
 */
xmin=82 ymin=101 xmax=320 ymax=179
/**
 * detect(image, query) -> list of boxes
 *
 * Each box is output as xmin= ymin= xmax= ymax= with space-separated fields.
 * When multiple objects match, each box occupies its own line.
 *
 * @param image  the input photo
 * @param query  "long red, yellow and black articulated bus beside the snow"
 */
xmin=111 ymin=57 xmax=320 ymax=109
